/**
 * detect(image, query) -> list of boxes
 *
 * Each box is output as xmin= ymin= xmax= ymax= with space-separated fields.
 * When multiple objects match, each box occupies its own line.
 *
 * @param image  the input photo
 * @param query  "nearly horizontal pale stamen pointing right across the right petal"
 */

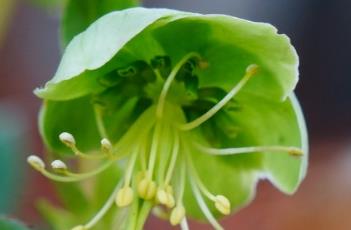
xmin=195 ymin=144 xmax=303 ymax=156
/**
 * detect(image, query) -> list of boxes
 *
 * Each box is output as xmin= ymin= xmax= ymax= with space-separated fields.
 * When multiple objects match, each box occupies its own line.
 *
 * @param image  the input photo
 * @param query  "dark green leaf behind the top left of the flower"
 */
xmin=61 ymin=0 xmax=140 ymax=46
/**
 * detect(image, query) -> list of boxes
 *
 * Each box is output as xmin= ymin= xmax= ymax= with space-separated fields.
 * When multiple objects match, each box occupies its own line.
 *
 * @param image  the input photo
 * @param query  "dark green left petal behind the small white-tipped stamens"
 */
xmin=39 ymin=97 xmax=101 ymax=154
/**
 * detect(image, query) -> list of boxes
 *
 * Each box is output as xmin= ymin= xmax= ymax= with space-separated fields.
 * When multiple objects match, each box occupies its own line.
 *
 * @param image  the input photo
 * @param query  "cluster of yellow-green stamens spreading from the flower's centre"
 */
xmin=28 ymin=53 xmax=302 ymax=230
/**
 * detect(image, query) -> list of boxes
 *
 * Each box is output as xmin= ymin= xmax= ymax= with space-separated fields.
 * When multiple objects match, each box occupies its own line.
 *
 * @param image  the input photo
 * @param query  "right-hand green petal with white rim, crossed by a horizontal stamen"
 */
xmin=219 ymin=93 xmax=308 ymax=194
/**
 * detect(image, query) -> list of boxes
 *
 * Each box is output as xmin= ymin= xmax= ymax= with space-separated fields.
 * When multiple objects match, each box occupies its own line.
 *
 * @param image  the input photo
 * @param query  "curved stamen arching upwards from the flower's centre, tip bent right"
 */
xmin=156 ymin=52 xmax=200 ymax=118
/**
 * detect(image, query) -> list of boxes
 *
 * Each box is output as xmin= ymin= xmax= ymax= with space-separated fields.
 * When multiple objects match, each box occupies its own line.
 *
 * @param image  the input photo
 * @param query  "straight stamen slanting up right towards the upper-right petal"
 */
xmin=180 ymin=64 xmax=258 ymax=131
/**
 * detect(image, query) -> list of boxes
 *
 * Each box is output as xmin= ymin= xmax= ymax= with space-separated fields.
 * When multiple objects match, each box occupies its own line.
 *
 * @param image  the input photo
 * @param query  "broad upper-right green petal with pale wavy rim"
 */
xmin=154 ymin=15 xmax=298 ymax=100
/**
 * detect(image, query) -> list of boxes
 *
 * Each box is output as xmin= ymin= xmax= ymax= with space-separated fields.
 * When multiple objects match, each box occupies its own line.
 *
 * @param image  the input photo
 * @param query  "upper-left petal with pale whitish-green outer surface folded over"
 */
xmin=35 ymin=8 xmax=184 ymax=100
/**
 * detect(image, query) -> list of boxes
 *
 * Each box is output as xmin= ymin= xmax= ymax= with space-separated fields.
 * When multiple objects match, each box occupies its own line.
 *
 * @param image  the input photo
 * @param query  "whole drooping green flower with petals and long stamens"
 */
xmin=28 ymin=8 xmax=307 ymax=229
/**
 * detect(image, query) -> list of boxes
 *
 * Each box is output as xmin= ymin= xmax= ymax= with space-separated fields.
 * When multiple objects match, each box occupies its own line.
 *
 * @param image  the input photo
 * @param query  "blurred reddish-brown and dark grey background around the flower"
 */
xmin=0 ymin=0 xmax=351 ymax=230
